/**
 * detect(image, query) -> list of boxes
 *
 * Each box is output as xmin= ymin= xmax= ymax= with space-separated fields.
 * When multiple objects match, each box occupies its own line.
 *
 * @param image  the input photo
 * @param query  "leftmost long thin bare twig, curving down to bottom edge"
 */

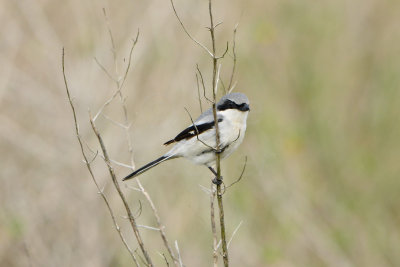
xmin=62 ymin=48 xmax=139 ymax=267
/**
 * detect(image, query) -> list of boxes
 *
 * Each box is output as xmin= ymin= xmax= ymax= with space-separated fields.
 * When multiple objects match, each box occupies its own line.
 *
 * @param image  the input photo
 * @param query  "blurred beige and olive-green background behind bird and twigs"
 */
xmin=0 ymin=0 xmax=400 ymax=267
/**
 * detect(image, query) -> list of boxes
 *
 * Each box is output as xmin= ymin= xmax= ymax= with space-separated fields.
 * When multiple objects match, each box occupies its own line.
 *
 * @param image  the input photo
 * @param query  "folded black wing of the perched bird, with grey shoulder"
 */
xmin=164 ymin=109 xmax=222 ymax=145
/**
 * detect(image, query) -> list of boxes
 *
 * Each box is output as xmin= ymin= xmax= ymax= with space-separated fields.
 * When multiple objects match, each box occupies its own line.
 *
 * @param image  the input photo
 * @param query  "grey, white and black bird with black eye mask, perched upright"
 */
xmin=122 ymin=92 xmax=250 ymax=181
